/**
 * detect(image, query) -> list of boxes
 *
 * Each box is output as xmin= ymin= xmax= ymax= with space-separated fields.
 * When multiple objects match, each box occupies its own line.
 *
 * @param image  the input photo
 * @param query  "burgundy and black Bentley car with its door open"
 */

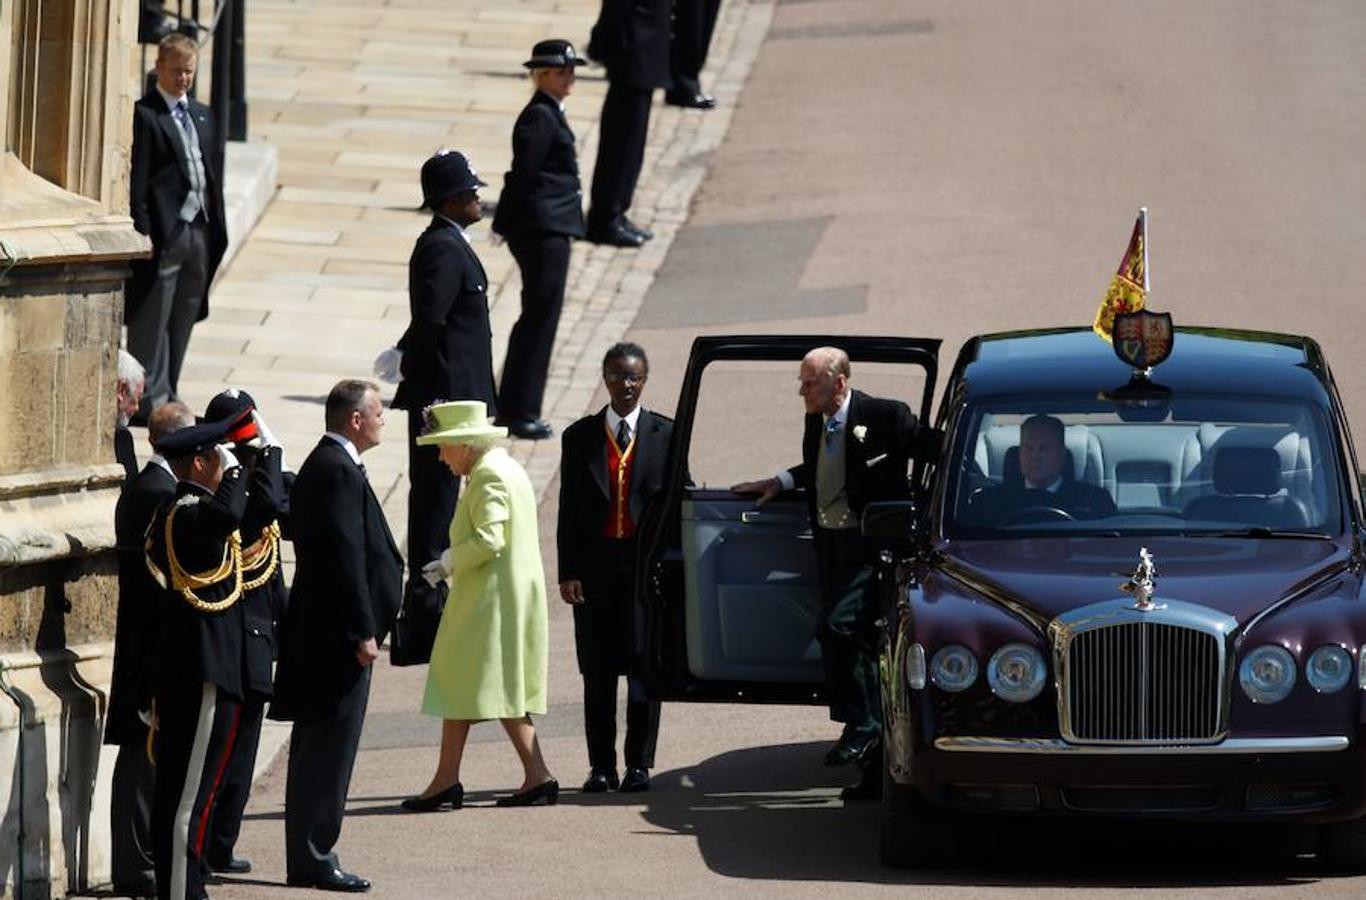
xmin=639 ymin=328 xmax=1366 ymax=867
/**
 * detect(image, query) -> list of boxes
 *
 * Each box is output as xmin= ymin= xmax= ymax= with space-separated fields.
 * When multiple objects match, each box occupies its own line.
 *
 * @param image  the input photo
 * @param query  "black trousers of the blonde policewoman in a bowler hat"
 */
xmin=499 ymin=234 xmax=570 ymax=422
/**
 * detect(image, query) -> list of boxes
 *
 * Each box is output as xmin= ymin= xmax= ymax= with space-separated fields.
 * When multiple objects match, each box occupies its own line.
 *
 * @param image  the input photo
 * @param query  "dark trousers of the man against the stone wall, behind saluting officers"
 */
xmin=109 ymin=727 xmax=157 ymax=893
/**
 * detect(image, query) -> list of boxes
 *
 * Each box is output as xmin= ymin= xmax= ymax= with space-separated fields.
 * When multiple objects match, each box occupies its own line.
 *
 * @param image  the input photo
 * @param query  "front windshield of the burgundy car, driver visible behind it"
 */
xmin=944 ymin=393 xmax=1343 ymax=539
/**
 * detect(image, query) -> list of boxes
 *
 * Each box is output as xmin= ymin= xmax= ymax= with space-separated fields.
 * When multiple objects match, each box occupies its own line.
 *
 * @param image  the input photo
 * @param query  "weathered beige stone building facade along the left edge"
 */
xmin=0 ymin=0 xmax=149 ymax=897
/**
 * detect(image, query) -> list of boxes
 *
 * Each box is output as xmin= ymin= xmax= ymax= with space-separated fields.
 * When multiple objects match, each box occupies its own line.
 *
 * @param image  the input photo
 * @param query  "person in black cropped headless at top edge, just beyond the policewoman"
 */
xmin=587 ymin=0 xmax=673 ymax=247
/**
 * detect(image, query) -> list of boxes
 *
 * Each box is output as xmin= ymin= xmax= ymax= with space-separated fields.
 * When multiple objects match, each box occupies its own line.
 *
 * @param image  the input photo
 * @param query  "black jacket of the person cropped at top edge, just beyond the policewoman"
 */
xmin=589 ymin=0 xmax=673 ymax=90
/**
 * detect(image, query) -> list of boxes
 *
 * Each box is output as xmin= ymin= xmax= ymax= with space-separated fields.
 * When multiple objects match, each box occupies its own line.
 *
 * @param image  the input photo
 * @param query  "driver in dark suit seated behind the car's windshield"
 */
xmin=968 ymin=415 xmax=1119 ymax=526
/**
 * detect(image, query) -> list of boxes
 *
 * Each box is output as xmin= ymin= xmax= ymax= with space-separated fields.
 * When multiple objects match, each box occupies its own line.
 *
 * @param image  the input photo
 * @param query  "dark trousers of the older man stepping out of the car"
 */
xmin=814 ymin=527 xmax=882 ymax=732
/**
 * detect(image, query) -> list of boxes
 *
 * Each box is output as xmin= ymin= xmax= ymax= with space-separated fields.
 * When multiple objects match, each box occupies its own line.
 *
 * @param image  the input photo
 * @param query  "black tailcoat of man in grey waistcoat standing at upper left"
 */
xmin=123 ymin=87 xmax=228 ymax=322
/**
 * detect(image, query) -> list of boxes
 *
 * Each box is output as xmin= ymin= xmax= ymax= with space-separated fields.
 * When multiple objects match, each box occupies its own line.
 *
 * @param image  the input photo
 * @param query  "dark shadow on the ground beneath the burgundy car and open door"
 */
xmin=636 ymin=743 xmax=1355 ymax=888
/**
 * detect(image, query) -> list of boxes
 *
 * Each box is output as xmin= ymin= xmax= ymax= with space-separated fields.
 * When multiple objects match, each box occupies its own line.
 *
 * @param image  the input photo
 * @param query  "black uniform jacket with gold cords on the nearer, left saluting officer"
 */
xmin=148 ymin=466 xmax=247 ymax=710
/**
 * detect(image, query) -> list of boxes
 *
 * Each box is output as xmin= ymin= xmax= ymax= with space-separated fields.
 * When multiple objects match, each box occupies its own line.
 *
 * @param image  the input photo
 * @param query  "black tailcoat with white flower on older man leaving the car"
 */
xmin=788 ymin=391 xmax=934 ymax=523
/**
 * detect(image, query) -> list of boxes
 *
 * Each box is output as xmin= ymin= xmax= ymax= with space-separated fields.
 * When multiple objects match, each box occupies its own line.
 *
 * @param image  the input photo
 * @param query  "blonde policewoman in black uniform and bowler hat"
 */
xmin=493 ymin=40 xmax=587 ymax=440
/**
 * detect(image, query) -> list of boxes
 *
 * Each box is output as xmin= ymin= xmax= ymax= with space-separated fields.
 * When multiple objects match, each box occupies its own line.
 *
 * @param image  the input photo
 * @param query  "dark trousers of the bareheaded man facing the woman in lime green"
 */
xmin=284 ymin=668 xmax=370 ymax=880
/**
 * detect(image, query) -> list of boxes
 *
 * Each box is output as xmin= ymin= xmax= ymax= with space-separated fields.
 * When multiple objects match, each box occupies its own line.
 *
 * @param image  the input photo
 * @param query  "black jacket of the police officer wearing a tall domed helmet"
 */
xmin=393 ymin=217 xmax=496 ymax=415
